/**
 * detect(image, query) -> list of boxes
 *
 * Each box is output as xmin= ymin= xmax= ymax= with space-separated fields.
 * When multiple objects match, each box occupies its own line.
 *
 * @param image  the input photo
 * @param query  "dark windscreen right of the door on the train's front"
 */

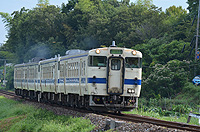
xmin=125 ymin=57 xmax=142 ymax=68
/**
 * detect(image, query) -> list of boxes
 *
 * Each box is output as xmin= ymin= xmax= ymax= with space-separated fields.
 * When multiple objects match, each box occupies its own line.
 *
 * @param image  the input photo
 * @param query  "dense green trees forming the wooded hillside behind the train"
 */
xmin=0 ymin=0 xmax=200 ymax=97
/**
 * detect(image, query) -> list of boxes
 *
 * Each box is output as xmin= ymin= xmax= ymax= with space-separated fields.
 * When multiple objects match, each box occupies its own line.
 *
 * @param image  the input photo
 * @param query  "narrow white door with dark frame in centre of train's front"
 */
xmin=107 ymin=57 xmax=124 ymax=95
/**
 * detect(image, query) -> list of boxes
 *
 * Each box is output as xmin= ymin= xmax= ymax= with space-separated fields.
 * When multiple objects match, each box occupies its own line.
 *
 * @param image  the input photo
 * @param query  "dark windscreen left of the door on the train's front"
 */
xmin=89 ymin=56 xmax=107 ymax=67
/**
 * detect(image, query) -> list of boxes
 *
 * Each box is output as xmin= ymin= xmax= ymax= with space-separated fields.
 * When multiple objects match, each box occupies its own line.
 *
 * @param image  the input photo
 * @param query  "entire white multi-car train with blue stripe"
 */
xmin=14 ymin=47 xmax=142 ymax=111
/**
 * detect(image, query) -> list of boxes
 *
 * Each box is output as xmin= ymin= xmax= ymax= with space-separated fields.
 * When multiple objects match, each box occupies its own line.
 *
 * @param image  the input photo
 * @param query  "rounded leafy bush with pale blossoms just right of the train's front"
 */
xmin=141 ymin=60 xmax=189 ymax=98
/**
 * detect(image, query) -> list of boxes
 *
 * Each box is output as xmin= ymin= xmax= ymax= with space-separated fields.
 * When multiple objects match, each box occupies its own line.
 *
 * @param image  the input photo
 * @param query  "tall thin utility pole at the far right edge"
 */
xmin=194 ymin=0 xmax=200 ymax=75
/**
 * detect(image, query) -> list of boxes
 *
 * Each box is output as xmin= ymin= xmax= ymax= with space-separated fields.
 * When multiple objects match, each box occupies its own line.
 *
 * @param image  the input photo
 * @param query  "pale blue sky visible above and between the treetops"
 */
xmin=0 ymin=0 xmax=188 ymax=45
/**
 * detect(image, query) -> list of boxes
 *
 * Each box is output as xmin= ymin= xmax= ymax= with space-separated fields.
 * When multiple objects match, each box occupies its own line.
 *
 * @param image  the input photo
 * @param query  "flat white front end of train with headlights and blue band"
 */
xmin=88 ymin=47 xmax=142 ymax=110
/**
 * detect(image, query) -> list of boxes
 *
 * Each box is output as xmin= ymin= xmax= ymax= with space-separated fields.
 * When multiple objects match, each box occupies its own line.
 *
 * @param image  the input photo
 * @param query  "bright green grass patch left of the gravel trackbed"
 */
xmin=0 ymin=96 xmax=95 ymax=132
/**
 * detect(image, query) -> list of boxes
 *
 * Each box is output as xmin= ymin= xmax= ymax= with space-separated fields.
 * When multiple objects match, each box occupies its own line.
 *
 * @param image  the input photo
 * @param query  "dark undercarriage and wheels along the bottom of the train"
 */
xmin=15 ymin=89 xmax=138 ymax=112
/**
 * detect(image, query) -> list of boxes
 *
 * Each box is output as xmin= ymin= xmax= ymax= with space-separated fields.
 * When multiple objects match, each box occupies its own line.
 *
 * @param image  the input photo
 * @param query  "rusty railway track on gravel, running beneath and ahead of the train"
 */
xmin=0 ymin=90 xmax=200 ymax=132
